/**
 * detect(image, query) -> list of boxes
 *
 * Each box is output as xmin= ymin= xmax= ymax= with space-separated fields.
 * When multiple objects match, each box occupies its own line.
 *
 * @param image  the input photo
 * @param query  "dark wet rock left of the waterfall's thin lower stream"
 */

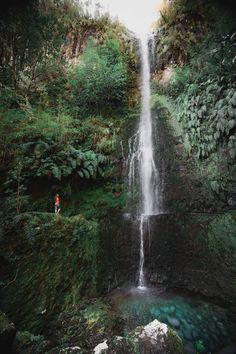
xmin=98 ymin=215 xmax=139 ymax=292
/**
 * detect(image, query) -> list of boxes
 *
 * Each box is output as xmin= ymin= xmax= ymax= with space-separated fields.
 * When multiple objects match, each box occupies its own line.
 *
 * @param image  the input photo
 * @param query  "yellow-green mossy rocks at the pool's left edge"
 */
xmin=44 ymin=299 xmax=125 ymax=353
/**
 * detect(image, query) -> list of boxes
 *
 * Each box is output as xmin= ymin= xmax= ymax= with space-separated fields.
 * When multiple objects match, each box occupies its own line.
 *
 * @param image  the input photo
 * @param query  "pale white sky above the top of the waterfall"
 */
xmin=86 ymin=0 xmax=163 ymax=33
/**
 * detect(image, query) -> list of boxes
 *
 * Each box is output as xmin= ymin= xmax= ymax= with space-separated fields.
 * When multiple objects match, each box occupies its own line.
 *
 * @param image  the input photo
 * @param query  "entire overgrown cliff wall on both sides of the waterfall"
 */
xmin=0 ymin=0 xmax=236 ymax=353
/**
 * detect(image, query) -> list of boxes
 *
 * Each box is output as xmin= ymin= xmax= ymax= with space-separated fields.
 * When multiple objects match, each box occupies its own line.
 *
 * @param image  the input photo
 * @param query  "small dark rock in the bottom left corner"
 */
xmin=0 ymin=311 xmax=16 ymax=354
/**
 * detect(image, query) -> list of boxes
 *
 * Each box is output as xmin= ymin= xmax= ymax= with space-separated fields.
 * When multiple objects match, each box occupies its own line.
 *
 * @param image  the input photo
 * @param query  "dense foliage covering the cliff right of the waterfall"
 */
xmin=154 ymin=0 xmax=236 ymax=203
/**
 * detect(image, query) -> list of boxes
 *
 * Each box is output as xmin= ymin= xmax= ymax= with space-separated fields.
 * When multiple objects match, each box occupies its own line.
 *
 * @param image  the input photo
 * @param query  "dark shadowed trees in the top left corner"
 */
xmin=0 ymin=0 xmax=64 ymax=88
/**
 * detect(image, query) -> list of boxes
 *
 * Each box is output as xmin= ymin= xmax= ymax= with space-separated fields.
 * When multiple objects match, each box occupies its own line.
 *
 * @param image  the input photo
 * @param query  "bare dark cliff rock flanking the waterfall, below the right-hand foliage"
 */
xmin=99 ymin=107 xmax=236 ymax=311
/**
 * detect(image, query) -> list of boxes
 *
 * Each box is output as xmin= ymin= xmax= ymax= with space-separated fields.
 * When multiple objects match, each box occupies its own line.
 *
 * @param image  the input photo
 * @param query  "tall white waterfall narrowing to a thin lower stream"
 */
xmin=127 ymin=35 xmax=161 ymax=288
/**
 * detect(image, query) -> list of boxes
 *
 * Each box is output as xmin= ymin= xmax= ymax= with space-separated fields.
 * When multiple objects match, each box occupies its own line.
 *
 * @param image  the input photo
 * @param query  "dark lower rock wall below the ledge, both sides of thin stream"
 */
xmin=101 ymin=211 xmax=236 ymax=306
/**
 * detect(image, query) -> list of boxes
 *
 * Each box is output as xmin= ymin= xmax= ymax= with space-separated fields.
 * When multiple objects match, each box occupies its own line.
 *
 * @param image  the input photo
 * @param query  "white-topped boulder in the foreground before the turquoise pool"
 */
xmin=93 ymin=320 xmax=185 ymax=354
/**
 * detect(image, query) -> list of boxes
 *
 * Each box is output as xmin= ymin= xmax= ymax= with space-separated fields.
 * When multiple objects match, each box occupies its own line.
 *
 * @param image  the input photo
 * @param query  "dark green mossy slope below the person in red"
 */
xmin=1 ymin=213 xmax=99 ymax=329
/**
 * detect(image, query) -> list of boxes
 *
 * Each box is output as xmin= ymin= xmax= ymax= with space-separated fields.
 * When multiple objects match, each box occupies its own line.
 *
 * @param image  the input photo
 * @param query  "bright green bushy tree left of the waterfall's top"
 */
xmin=72 ymin=39 xmax=127 ymax=115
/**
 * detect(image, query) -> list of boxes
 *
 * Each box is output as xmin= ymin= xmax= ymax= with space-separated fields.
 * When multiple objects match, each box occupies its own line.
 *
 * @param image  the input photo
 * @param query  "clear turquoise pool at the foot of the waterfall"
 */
xmin=110 ymin=288 xmax=236 ymax=354
